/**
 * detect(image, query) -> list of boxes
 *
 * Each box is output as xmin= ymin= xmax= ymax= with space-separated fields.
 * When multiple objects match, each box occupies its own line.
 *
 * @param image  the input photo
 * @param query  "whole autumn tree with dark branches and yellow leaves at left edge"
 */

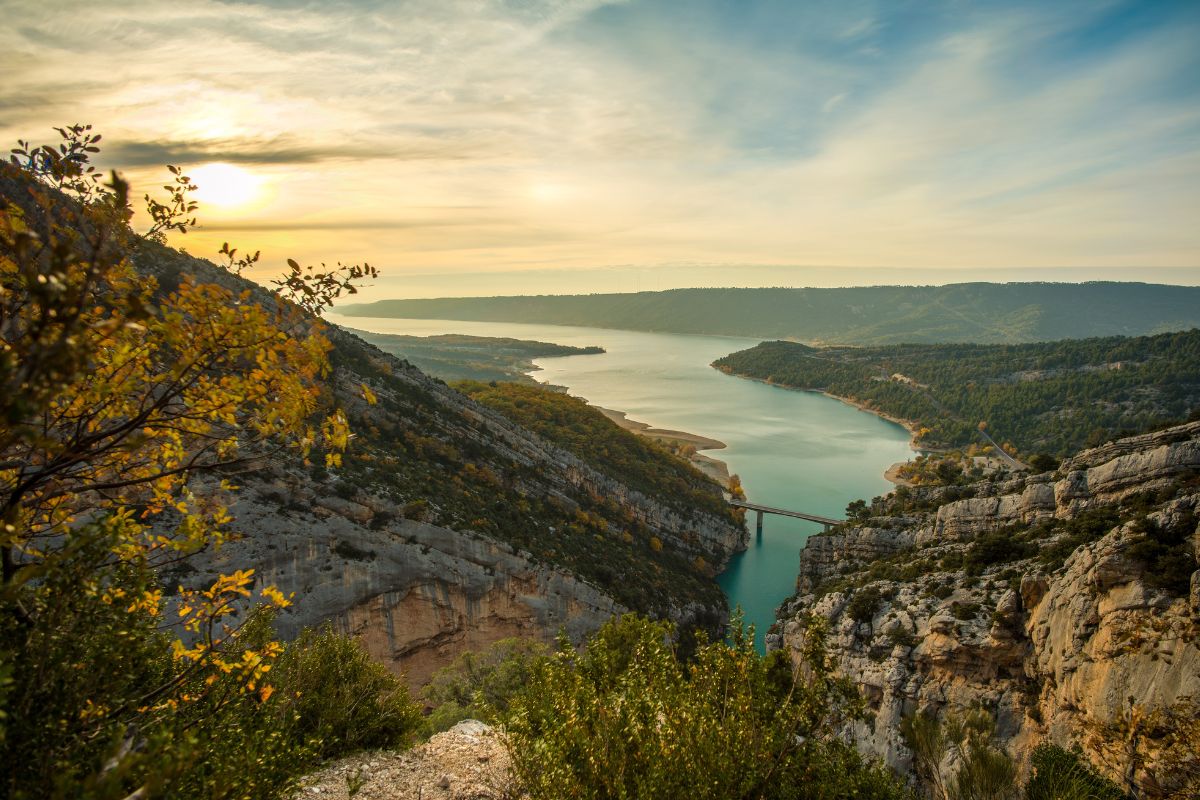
xmin=0 ymin=125 xmax=374 ymax=792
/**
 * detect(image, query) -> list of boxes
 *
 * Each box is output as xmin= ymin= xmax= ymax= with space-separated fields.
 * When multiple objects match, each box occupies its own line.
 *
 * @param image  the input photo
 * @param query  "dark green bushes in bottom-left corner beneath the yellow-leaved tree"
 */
xmin=0 ymin=529 xmax=420 ymax=800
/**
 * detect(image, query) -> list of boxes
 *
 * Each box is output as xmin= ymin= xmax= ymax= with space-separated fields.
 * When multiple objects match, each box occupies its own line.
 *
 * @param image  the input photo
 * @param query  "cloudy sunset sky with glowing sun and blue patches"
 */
xmin=0 ymin=0 xmax=1200 ymax=300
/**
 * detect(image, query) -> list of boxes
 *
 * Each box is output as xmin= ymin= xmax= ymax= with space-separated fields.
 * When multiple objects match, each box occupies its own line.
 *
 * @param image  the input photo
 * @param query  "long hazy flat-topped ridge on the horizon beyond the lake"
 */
xmin=338 ymin=282 xmax=1200 ymax=344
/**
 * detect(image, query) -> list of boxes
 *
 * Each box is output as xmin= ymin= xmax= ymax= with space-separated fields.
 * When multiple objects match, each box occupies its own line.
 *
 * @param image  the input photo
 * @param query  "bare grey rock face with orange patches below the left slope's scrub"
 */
xmin=192 ymin=497 xmax=628 ymax=686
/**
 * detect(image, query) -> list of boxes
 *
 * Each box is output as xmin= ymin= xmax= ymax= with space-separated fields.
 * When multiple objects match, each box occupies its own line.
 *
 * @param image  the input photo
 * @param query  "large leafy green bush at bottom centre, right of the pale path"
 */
xmin=506 ymin=615 xmax=906 ymax=800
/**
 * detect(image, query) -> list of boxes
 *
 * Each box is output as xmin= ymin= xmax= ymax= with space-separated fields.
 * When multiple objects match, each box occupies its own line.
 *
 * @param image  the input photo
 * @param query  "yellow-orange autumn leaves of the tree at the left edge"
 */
xmin=0 ymin=133 xmax=374 ymax=714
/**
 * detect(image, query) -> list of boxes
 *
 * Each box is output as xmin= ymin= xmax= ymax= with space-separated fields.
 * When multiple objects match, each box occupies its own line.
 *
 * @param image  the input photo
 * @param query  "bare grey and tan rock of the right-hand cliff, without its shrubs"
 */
xmin=772 ymin=422 xmax=1200 ymax=786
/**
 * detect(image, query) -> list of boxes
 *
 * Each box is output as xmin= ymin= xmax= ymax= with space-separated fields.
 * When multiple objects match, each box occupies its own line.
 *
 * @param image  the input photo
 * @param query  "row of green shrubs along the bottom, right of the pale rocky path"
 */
xmin=425 ymin=615 xmax=1124 ymax=800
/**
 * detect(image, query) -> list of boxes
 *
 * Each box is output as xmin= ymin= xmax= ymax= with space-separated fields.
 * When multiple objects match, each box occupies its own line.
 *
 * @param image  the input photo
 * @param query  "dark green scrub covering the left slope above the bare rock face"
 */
xmin=316 ymin=345 xmax=737 ymax=618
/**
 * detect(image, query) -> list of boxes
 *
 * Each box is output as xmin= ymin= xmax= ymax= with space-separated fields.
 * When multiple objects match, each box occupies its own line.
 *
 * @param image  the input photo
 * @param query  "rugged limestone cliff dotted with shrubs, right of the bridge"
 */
xmin=768 ymin=423 xmax=1200 ymax=796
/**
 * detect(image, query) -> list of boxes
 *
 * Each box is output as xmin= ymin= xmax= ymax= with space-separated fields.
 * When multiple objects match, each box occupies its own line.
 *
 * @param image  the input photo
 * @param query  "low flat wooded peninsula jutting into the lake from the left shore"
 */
xmin=350 ymin=329 xmax=604 ymax=384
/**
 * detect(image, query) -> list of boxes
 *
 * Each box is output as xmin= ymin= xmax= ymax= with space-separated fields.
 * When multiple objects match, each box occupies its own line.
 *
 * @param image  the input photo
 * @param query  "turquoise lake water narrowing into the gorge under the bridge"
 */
xmin=330 ymin=314 xmax=912 ymax=645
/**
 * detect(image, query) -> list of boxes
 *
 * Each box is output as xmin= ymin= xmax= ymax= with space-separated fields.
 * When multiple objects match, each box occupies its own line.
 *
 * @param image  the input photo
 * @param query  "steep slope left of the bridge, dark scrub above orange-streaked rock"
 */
xmin=139 ymin=245 xmax=745 ymax=684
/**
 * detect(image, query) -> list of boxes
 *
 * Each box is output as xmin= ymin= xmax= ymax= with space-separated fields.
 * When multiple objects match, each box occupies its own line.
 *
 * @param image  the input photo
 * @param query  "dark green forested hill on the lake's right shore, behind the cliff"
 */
xmin=713 ymin=330 xmax=1200 ymax=456
